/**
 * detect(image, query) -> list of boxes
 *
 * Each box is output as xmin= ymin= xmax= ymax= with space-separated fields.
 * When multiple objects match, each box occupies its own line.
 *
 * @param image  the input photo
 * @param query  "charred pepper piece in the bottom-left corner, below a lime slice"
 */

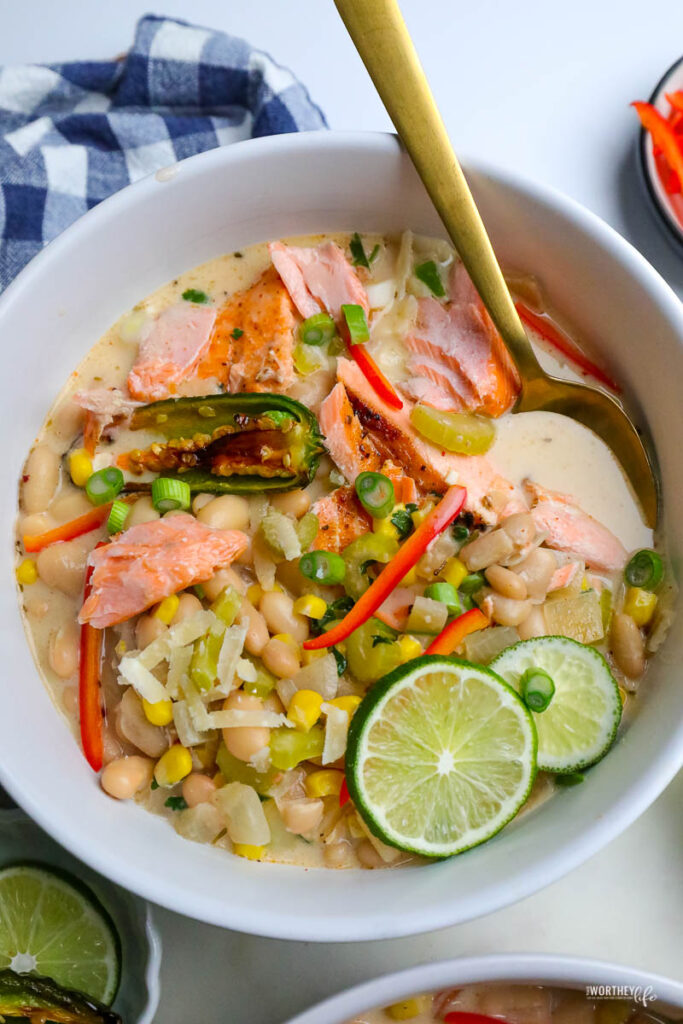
xmin=0 ymin=971 xmax=122 ymax=1024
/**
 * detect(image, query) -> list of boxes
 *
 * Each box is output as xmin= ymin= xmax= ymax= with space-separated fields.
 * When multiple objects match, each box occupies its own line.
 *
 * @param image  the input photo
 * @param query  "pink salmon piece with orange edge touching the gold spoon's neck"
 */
xmin=402 ymin=260 xmax=519 ymax=417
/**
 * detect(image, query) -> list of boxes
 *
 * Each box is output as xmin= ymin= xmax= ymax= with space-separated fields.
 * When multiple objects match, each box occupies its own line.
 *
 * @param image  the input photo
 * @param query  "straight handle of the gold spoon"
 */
xmin=335 ymin=0 xmax=542 ymax=382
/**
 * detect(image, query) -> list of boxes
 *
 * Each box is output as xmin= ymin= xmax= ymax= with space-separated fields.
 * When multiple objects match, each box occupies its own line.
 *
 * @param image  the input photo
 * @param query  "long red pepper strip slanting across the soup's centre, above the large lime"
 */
xmin=303 ymin=486 xmax=467 ymax=650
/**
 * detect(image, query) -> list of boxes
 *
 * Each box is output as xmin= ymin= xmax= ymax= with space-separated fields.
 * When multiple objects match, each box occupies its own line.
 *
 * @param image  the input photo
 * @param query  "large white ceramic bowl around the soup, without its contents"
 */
xmin=0 ymin=133 xmax=683 ymax=941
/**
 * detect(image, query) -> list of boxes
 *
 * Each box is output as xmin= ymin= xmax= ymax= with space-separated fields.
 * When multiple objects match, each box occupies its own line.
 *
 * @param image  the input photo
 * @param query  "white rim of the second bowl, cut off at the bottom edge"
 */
xmin=289 ymin=953 xmax=683 ymax=1024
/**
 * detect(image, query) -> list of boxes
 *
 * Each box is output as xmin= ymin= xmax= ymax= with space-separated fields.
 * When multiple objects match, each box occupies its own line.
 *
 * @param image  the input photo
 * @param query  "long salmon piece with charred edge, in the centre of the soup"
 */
xmin=337 ymin=358 xmax=527 ymax=523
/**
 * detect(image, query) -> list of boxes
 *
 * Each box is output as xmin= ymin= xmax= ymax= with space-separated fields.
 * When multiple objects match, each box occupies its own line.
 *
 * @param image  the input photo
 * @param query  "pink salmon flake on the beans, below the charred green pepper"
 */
xmin=79 ymin=515 xmax=249 ymax=630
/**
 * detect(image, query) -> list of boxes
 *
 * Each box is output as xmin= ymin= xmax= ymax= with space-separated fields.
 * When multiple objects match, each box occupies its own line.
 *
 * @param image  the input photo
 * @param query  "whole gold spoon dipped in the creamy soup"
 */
xmin=335 ymin=0 xmax=658 ymax=527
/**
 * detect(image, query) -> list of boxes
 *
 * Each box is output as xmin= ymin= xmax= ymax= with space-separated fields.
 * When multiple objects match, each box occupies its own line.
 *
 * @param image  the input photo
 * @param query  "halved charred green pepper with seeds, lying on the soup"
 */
xmin=124 ymin=393 xmax=325 ymax=494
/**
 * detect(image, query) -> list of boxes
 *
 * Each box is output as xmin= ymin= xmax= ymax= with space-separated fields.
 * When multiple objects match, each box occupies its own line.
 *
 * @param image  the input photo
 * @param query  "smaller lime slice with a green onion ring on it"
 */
xmin=492 ymin=637 xmax=622 ymax=772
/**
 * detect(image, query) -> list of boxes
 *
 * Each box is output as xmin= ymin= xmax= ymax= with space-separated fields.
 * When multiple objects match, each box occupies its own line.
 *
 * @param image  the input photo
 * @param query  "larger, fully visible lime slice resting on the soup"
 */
xmin=346 ymin=656 xmax=537 ymax=857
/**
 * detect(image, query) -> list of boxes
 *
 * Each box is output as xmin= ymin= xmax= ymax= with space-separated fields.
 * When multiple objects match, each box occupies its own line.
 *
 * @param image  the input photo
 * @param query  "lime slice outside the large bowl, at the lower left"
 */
xmin=0 ymin=864 xmax=121 ymax=1006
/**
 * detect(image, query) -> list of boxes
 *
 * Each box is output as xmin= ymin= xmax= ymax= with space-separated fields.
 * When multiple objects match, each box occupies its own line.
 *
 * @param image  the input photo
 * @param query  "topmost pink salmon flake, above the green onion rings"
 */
xmin=268 ymin=242 xmax=370 ymax=319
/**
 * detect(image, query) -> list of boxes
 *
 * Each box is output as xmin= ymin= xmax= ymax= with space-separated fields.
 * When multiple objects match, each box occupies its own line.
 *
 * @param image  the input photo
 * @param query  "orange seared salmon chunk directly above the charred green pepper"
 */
xmin=197 ymin=267 xmax=297 ymax=393
